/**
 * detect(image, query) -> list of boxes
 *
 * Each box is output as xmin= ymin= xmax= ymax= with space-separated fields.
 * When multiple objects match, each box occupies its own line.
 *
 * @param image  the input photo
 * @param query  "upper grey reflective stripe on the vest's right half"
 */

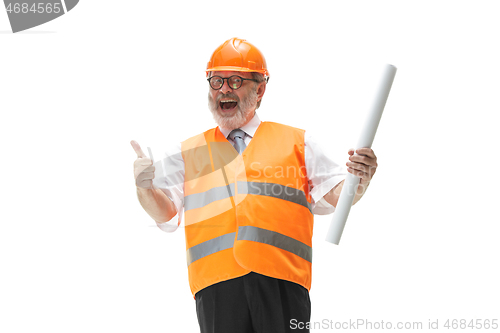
xmin=238 ymin=182 xmax=312 ymax=213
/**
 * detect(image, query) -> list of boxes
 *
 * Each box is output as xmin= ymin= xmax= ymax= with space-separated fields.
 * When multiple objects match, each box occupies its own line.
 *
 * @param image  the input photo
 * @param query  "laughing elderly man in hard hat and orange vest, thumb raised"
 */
xmin=131 ymin=38 xmax=377 ymax=333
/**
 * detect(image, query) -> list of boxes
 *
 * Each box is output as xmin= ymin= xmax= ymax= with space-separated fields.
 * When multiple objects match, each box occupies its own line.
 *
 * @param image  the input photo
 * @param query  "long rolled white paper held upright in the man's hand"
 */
xmin=326 ymin=64 xmax=397 ymax=245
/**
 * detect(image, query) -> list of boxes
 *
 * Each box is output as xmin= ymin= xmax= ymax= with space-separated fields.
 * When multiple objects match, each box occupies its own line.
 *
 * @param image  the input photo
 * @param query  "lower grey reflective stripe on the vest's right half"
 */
xmin=238 ymin=226 xmax=312 ymax=263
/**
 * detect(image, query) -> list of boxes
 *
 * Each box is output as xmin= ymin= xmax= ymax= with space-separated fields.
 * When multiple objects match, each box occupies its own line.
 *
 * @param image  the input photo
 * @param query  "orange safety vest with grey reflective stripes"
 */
xmin=182 ymin=122 xmax=313 ymax=296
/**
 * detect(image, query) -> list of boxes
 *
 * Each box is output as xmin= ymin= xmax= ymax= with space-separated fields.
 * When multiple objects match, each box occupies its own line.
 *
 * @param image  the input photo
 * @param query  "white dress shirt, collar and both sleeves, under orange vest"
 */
xmin=154 ymin=113 xmax=347 ymax=232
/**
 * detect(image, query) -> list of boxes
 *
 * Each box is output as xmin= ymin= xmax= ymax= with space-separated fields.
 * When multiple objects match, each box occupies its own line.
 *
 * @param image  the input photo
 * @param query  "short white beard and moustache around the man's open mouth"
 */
xmin=208 ymin=89 xmax=259 ymax=130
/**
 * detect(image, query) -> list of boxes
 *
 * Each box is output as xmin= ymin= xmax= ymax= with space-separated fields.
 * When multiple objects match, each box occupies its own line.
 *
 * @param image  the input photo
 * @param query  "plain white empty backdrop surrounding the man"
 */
xmin=0 ymin=0 xmax=500 ymax=333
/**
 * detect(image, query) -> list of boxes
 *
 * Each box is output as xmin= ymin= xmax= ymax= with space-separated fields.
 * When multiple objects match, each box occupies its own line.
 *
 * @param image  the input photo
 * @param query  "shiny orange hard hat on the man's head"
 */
xmin=206 ymin=37 xmax=269 ymax=78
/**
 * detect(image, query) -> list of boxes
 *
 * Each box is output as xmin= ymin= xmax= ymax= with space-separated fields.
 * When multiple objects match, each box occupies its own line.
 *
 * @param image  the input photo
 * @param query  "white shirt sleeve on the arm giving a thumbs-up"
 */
xmin=153 ymin=142 xmax=184 ymax=232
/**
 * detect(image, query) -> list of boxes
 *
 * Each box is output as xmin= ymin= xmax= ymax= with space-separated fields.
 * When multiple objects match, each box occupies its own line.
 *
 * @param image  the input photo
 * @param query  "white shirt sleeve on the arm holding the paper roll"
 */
xmin=304 ymin=131 xmax=347 ymax=215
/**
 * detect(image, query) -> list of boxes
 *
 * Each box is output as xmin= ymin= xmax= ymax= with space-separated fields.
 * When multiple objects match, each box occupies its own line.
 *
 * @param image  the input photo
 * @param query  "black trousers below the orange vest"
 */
xmin=195 ymin=272 xmax=311 ymax=333
